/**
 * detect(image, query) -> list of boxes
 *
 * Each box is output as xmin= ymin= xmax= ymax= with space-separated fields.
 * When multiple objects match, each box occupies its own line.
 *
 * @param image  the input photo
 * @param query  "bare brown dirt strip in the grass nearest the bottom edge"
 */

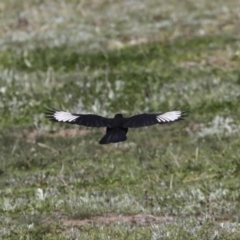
xmin=62 ymin=214 xmax=174 ymax=227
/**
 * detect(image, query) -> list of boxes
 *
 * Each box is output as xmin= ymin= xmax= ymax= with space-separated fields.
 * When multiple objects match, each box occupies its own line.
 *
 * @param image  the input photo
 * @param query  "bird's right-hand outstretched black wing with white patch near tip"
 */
xmin=123 ymin=110 xmax=187 ymax=128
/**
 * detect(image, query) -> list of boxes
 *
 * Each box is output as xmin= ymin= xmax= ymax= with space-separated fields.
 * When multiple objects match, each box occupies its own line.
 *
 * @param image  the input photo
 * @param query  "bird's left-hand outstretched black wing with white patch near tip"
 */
xmin=45 ymin=108 xmax=112 ymax=127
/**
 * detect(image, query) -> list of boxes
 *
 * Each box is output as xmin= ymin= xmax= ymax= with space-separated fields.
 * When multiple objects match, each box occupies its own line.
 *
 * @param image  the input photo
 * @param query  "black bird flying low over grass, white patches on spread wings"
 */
xmin=45 ymin=108 xmax=186 ymax=144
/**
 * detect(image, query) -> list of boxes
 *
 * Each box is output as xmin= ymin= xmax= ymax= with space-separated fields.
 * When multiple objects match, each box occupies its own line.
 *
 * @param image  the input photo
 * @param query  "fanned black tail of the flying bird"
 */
xmin=99 ymin=129 xmax=127 ymax=144
